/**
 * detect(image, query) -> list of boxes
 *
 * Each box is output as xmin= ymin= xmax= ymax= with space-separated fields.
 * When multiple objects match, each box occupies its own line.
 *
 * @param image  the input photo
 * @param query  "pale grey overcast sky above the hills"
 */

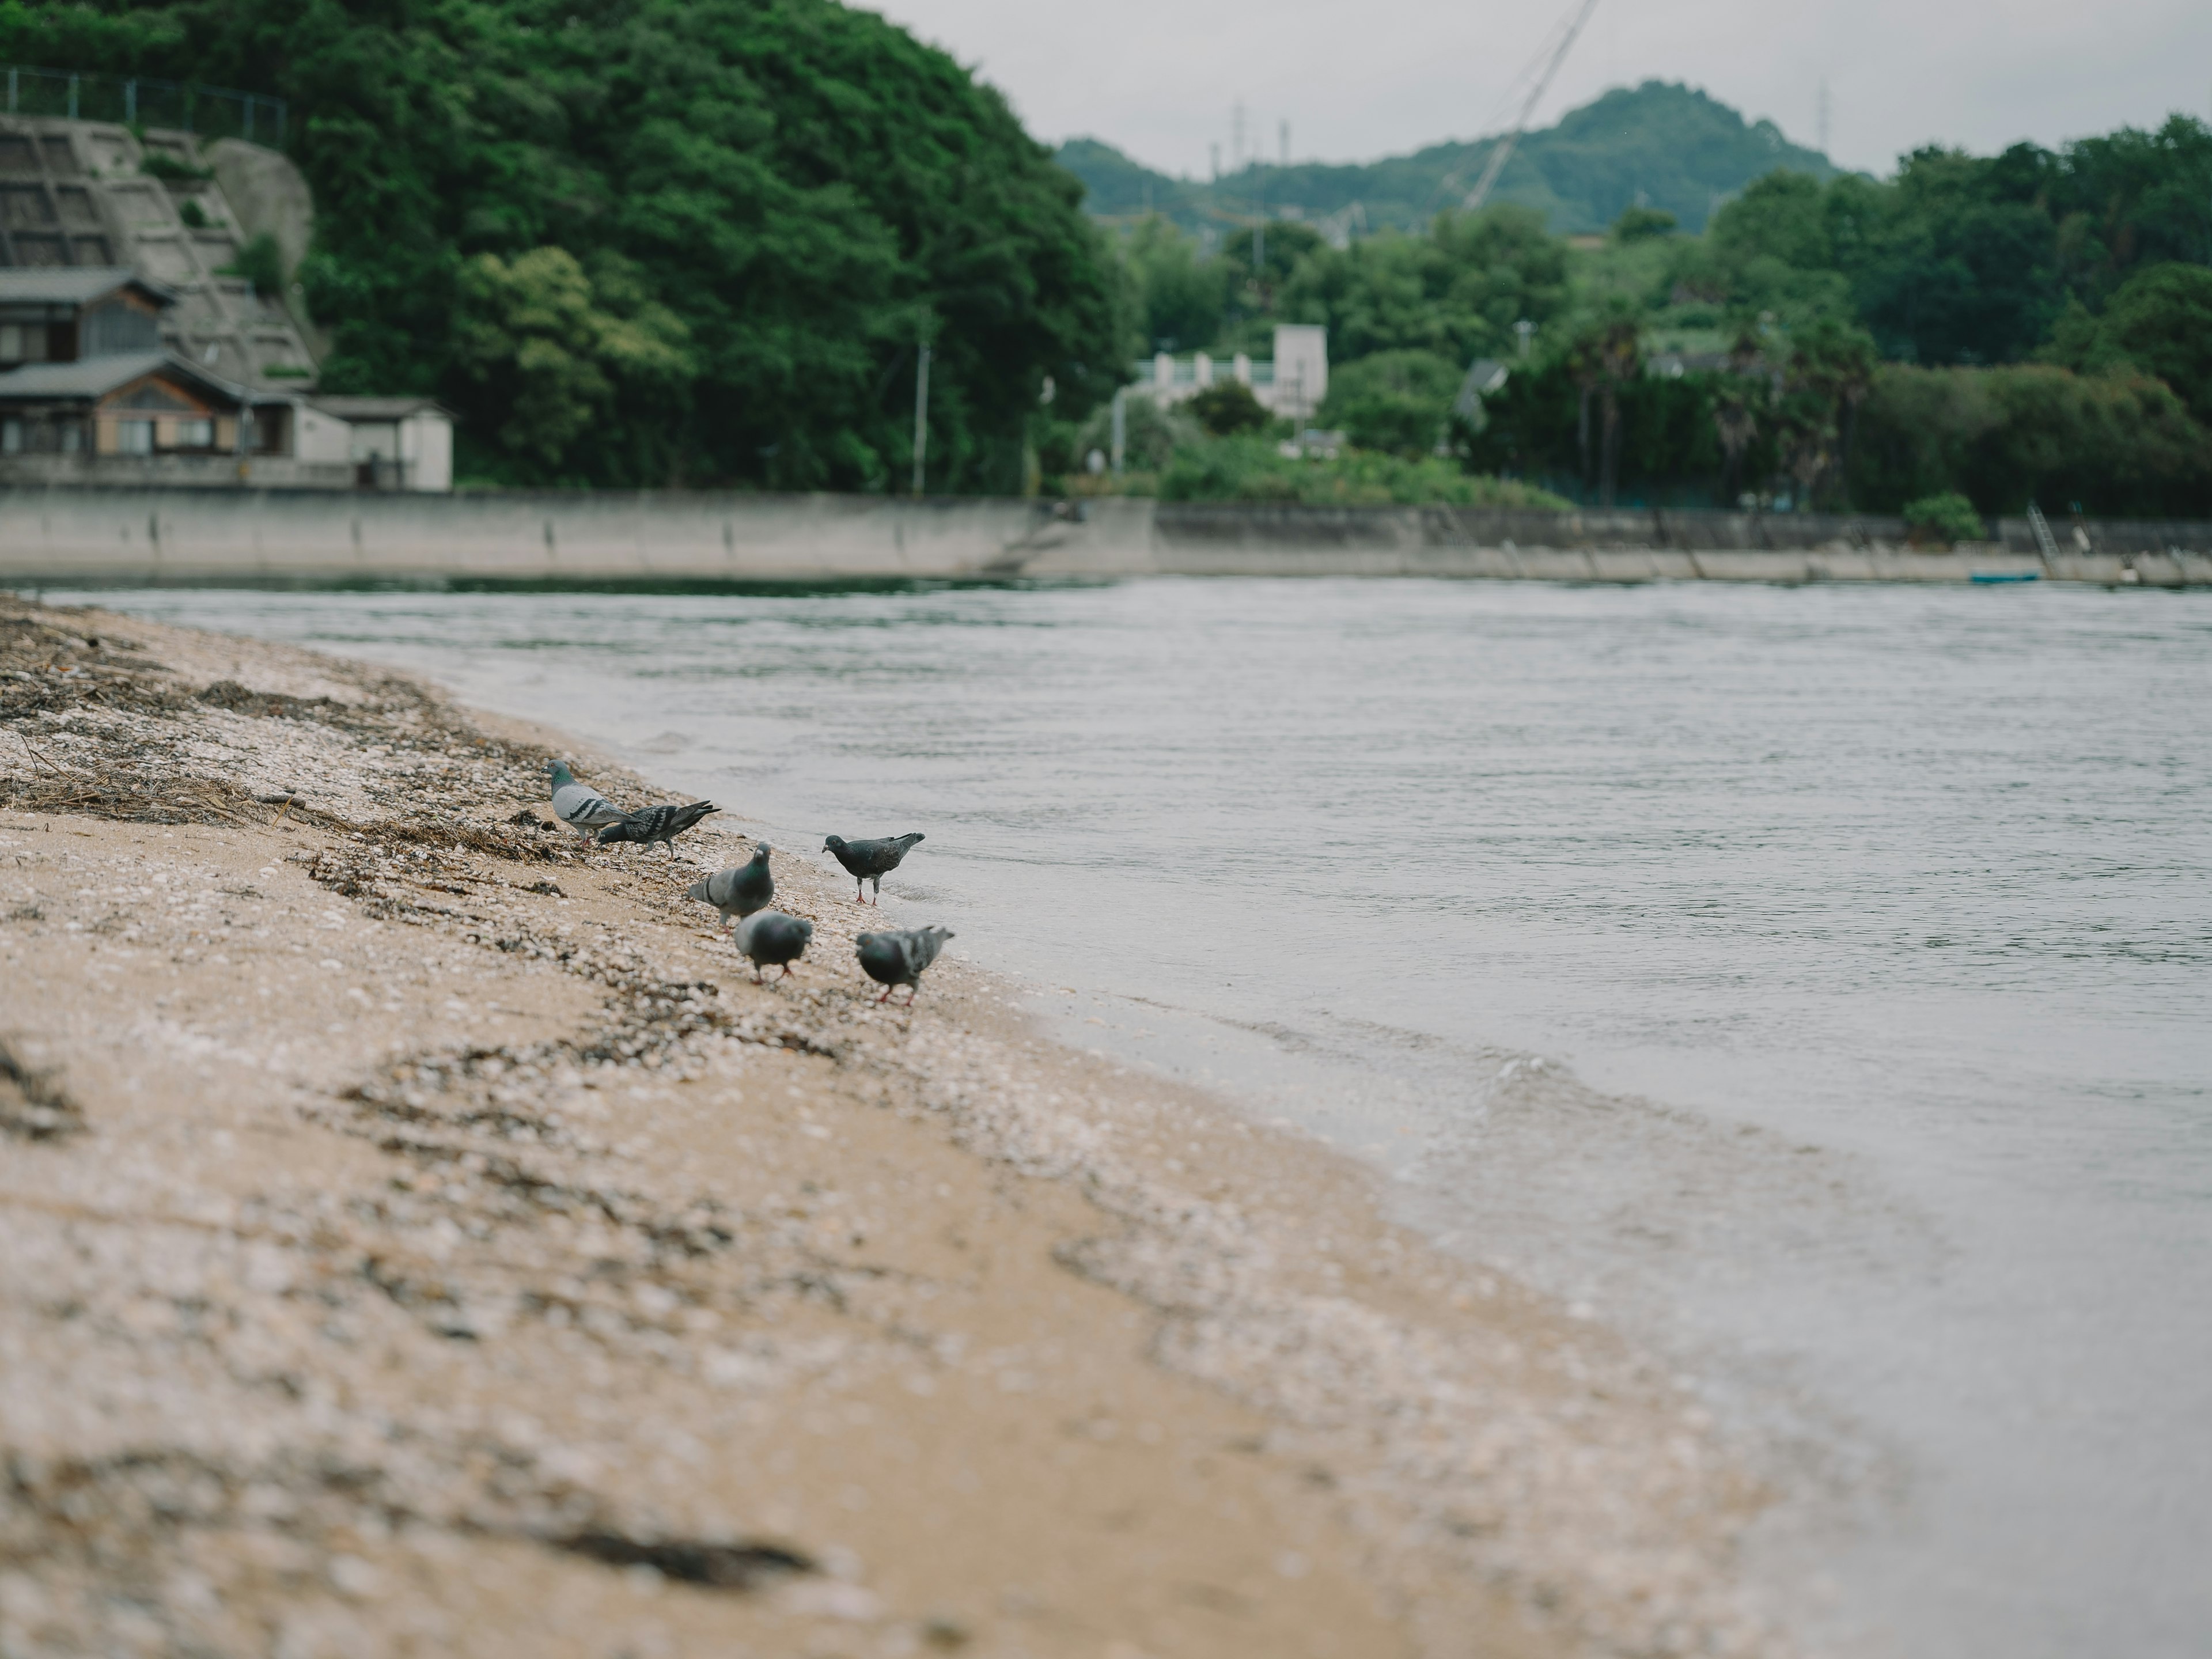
xmin=882 ymin=0 xmax=2212 ymax=175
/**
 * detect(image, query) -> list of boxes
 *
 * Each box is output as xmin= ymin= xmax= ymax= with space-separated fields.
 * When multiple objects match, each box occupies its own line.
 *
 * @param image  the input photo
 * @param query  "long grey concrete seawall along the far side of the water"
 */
xmin=0 ymin=489 xmax=2212 ymax=586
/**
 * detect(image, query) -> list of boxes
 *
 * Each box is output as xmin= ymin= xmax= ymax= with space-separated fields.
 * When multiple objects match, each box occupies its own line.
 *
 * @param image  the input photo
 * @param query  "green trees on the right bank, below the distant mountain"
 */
xmin=1097 ymin=115 xmax=2212 ymax=522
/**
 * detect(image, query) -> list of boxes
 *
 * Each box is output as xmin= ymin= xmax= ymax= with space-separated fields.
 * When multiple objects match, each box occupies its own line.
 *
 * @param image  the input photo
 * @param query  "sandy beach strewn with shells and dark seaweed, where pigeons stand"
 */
xmin=0 ymin=600 xmax=1783 ymax=1659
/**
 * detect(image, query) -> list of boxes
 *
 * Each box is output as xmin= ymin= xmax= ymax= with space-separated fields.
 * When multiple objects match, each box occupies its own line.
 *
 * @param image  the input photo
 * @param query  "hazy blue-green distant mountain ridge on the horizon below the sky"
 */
xmin=1059 ymin=79 xmax=1836 ymax=241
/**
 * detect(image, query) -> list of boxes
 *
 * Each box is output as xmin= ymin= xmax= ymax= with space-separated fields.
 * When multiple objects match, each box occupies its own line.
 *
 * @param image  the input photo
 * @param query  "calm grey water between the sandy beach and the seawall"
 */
xmin=65 ymin=582 xmax=2212 ymax=1659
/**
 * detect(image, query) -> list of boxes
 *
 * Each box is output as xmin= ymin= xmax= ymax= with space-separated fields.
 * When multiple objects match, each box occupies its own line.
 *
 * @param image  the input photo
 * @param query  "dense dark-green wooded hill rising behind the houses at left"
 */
xmin=0 ymin=0 xmax=1126 ymax=491
